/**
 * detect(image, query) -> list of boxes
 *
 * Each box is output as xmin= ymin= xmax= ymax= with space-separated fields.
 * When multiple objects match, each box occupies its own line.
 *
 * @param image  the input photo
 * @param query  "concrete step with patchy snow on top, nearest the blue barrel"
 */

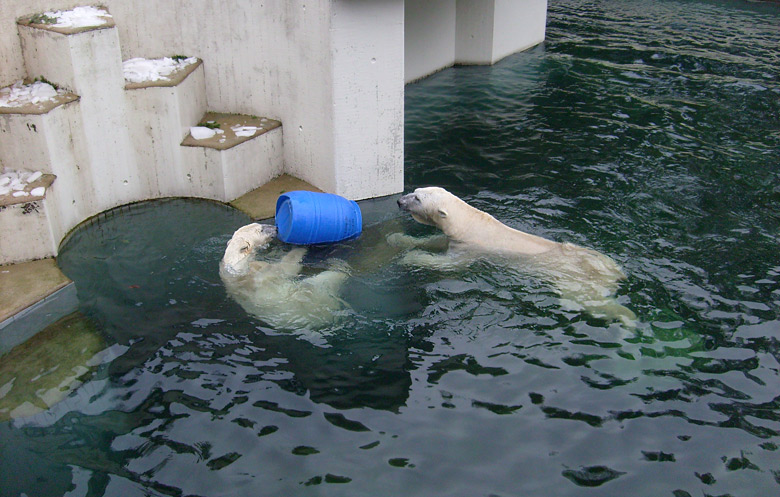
xmin=181 ymin=112 xmax=284 ymax=202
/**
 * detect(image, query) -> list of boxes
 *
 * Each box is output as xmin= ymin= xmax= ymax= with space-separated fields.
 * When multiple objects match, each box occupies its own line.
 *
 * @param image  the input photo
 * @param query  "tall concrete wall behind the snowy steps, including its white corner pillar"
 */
xmin=0 ymin=0 xmax=404 ymax=199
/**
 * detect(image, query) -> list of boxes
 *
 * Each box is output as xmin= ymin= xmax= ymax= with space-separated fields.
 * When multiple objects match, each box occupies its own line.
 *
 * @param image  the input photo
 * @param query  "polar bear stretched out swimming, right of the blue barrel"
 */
xmin=388 ymin=187 xmax=636 ymax=326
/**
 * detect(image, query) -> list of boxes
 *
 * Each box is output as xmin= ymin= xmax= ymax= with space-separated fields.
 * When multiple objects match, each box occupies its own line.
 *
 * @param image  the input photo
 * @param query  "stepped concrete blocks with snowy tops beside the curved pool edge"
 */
xmin=0 ymin=4 xmax=283 ymax=265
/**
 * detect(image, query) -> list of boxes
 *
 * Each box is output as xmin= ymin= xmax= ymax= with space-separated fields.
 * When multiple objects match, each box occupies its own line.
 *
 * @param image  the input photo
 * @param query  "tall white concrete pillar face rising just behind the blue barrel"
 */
xmin=329 ymin=0 xmax=404 ymax=199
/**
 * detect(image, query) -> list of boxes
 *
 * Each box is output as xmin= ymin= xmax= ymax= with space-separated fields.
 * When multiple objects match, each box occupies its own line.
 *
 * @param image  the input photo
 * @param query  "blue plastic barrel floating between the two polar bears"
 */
xmin=276 ymin=190 xmax=363 ymax=245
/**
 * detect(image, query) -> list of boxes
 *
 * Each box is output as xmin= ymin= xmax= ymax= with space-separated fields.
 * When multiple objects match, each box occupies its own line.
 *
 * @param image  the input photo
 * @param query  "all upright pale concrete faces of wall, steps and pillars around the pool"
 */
xmin=0 ymin=0 xmax=546 ymax=264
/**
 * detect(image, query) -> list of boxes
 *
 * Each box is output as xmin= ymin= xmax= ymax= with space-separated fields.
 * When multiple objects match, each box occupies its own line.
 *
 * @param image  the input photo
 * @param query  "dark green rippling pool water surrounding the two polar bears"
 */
xmin=0 ymin=0 xmax=780 ymax=497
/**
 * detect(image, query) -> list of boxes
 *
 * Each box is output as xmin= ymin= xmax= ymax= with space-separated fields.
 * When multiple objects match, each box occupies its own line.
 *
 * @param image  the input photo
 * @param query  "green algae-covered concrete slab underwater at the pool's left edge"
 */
xmin=0 ymin=312 xmax=105 ymax=422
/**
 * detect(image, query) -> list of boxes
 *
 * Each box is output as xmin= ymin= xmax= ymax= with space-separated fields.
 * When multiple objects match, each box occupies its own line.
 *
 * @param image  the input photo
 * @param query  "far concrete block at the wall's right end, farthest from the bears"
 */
xmin=455 ymin=0 xmax=547 ymax=64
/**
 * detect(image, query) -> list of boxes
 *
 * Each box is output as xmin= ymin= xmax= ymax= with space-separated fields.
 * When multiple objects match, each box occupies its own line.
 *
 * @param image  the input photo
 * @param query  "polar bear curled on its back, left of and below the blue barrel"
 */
xmin=219 ymin=223 xmax=349 ymax=330
